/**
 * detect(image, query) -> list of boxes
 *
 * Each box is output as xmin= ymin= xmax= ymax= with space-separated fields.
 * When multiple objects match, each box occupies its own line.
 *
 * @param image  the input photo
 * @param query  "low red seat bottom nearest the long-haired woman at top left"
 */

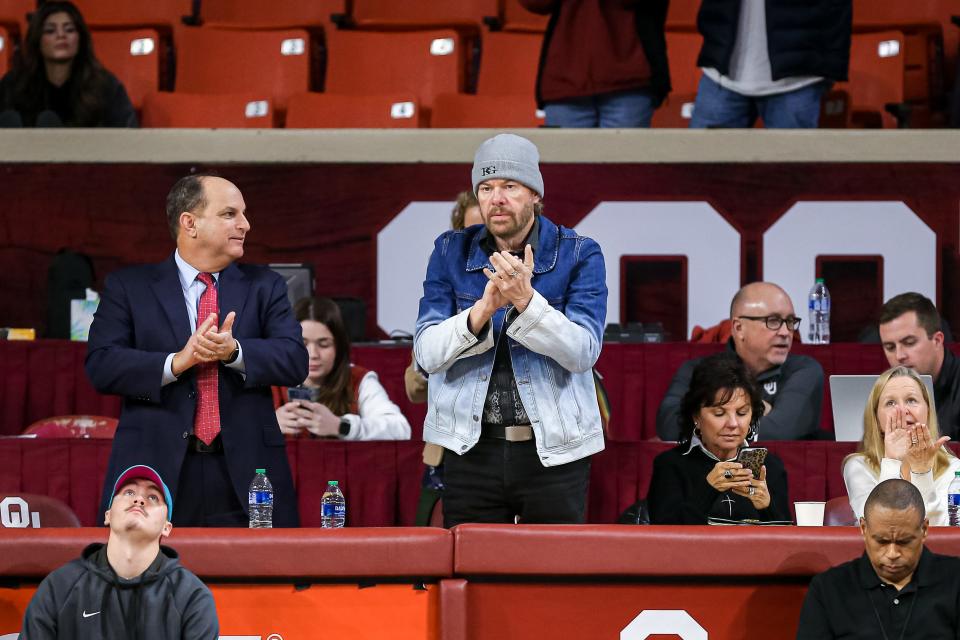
xmin=140 ymin=92 xmax=273 ymax=129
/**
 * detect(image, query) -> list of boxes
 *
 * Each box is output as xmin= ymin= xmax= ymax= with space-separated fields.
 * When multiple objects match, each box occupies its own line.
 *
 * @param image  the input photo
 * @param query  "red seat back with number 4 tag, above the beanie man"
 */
xmin=325 ymin=30 xmax=465 ymax=112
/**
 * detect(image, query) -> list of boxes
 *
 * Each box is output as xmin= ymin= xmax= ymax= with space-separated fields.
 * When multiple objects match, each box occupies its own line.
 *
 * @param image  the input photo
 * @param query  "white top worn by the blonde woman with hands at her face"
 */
xmin=843 ymin=454 xmax=960 ymax=527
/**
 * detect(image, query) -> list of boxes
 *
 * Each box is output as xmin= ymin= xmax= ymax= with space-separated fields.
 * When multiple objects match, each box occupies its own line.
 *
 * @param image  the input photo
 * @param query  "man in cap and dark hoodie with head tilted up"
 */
xmin=20 ymin=465 xmax=220 ymax=640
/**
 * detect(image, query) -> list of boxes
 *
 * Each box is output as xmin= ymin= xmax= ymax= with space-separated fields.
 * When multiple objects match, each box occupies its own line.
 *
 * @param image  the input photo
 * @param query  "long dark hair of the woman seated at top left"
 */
xmin=10 ymin=0 xmax=110 ymax=127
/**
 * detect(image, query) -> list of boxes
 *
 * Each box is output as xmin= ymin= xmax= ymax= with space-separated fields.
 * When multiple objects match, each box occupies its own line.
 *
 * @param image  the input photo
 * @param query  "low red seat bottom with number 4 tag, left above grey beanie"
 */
xmin=286 ymin=93 xmax=421 ymax=129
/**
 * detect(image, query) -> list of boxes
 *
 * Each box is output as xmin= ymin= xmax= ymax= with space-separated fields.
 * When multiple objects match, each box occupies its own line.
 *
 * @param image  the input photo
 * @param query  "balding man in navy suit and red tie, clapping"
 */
xmin=86 ymin=175 xmax=307 ymax=527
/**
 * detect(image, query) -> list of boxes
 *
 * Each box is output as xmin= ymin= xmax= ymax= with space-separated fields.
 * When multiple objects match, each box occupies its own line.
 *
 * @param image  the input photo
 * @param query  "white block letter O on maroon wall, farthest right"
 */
xmin=763 ymin=201 xmax=937 ymax=342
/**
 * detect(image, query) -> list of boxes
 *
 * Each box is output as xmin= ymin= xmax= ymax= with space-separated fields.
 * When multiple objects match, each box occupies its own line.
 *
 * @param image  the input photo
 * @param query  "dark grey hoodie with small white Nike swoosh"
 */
xmin=20 ymin=543 xmax=220 ymax=640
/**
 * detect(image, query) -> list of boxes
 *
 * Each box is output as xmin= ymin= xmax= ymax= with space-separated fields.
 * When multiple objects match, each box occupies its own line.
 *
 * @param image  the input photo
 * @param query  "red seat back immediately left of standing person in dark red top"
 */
xmin=477 ymin=32 xmax=543 ymax=96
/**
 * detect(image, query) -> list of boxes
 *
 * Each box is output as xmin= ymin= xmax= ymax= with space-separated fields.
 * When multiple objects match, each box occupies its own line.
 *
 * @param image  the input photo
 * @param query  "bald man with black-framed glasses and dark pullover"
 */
xmin=657 ymin=282 xmax=823 ymax=440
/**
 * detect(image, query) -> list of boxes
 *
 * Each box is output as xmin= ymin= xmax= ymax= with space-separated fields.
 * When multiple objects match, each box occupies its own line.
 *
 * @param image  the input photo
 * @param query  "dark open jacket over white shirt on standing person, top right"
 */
xmin=697 ymin=0 xmax=853 ymax=80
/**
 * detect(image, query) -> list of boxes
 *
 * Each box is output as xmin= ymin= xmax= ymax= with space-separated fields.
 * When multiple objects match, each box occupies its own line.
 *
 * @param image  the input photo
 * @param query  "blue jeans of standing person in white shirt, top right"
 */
xmin=690 ymin=75 xmax=830 ymax=129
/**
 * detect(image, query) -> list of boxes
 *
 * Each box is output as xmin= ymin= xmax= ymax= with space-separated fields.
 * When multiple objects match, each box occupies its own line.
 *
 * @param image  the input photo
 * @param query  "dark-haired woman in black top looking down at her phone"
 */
xmin=647 ymin=351 xmax=790 ymax=524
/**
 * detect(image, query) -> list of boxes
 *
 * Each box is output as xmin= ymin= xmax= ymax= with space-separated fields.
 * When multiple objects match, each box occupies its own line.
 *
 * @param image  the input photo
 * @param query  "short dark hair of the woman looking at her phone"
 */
xmin=679 ymin=351 xmax=763 ymax=443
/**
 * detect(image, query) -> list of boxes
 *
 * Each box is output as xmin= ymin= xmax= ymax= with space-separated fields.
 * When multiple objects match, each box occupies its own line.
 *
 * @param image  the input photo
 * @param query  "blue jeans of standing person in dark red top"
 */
xmin=543 ymin=91 xmax=655 ymax=129
